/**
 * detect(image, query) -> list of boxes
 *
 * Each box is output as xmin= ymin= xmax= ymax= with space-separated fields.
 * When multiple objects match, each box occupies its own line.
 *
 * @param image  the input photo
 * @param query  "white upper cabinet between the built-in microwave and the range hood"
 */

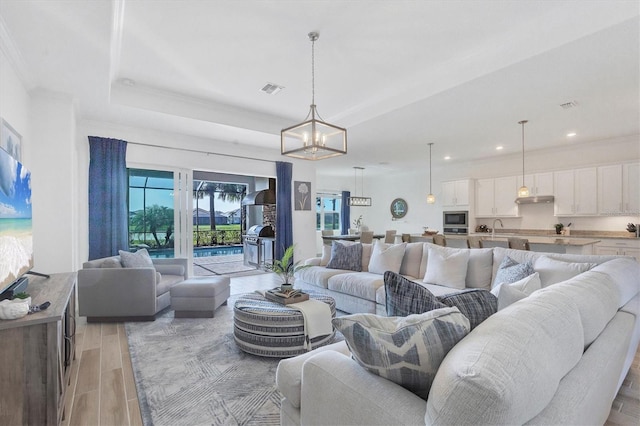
xmin=475 ymin=176 xmax=518 ymax=217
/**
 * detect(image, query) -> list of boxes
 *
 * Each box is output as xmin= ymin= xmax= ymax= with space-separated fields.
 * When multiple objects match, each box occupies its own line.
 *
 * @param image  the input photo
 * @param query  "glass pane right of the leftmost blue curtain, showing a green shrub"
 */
xmin=128 ymin=169 xmax=174 ymax=257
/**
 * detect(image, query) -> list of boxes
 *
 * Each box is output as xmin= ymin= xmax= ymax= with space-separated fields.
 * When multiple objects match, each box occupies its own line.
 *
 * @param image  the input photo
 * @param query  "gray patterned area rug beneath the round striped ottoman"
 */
xmin=125 ymin=295 xmax=341 ymax=426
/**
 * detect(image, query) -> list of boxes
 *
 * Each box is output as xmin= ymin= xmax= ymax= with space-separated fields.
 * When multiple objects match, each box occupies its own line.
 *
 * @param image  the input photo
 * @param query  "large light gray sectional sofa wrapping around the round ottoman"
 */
xmin=276 ymin=245 xmax=640 ymax=425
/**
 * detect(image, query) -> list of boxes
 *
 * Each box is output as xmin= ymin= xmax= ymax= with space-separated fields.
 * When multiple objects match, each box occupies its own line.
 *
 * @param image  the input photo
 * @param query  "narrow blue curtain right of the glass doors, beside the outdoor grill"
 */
xmin=275 ymin=161 xmax=293 ymax=259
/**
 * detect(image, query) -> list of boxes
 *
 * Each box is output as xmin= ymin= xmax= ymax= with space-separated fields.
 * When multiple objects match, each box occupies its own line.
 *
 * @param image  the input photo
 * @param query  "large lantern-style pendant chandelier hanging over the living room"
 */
xmin=280 ymin=32 xmax=347 ymax=160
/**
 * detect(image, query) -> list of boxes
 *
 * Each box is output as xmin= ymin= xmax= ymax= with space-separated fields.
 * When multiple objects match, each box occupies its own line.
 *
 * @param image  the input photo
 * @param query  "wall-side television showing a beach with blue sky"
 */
xmin=0 ymin=148 xmax=33 ymax=298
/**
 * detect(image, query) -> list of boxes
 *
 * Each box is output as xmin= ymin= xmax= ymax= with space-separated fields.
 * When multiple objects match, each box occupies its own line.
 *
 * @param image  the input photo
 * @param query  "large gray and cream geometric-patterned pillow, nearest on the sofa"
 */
xmin=333 ymin=308 xmax=469 ymax=400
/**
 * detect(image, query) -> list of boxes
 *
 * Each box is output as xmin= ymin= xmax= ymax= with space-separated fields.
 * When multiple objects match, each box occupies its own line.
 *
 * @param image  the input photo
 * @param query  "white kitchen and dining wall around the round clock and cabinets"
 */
xmin=318 ymin=135 xmax=640 ymax=234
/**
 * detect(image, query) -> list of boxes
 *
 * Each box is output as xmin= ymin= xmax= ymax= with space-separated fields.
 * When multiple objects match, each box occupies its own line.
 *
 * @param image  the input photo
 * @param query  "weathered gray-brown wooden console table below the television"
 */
xmin=0 ymin=273 xmax=76 ymax=425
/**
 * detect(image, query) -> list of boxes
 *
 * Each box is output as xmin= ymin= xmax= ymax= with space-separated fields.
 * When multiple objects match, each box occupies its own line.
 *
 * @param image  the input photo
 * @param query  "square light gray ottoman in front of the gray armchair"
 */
xmin=170 ymin=276 xmax=231 ymax=318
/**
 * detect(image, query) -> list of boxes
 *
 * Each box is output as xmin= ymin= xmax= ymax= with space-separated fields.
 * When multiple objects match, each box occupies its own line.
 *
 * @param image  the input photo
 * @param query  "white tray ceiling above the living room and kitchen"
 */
xmin=0 ymin=0 xmax=640 ymax=176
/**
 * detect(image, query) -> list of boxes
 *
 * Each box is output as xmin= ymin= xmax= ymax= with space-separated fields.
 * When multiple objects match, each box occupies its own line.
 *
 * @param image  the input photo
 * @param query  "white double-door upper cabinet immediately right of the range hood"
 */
xmin=553 ymin=167 xmax=598 ymax=216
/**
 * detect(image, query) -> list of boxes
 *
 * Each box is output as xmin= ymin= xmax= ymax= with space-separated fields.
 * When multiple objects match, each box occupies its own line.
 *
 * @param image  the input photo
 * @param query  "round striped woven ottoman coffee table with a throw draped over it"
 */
xmin=233 ymin=293 xmax=336 ymax=358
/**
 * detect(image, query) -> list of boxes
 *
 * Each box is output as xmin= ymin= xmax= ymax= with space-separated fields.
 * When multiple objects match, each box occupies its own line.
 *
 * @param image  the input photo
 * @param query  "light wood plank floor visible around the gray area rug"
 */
xmin=62 ymin=274 xmax=640 ymax=426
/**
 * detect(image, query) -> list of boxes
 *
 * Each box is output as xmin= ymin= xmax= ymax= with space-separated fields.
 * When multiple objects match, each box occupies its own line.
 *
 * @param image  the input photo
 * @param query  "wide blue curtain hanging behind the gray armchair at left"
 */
xmin=89 ymin=136 xmax=129 ymax=260
